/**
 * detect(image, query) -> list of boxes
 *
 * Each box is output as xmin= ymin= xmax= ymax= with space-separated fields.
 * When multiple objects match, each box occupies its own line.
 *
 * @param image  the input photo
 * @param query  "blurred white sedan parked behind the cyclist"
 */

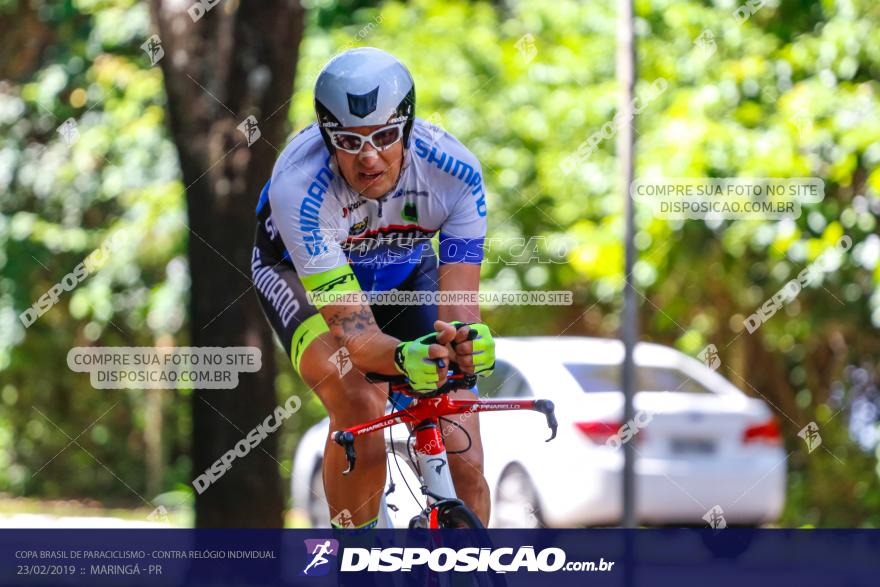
xmin=292 ymin=337 xmax=786 ymax=527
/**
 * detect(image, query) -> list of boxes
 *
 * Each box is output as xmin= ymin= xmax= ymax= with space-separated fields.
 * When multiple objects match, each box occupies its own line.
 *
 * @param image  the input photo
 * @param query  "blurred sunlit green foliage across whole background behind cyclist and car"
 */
xmin=0 ymin=0 xmax=880 ymax=527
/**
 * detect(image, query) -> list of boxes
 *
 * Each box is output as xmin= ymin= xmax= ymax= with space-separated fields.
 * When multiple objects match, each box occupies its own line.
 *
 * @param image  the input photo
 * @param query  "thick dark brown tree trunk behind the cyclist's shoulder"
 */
xmin=151 ymin=0 xmax=303 ymax=527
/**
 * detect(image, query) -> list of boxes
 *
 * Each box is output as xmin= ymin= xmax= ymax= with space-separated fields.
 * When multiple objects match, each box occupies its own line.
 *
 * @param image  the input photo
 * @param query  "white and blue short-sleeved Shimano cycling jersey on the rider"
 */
xmin=254 ymin=118 xmax=486 ymax=291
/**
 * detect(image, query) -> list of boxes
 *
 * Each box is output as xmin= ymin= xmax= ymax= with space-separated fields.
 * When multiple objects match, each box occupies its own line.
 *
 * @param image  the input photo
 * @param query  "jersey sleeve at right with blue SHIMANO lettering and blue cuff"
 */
xmin=440 ymin=157 xmax=487 ymax=265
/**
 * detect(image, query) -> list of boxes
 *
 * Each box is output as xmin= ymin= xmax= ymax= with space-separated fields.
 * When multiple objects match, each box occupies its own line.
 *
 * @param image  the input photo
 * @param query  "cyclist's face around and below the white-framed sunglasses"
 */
xmin=335 ymin=124 xmax=403 ymax=200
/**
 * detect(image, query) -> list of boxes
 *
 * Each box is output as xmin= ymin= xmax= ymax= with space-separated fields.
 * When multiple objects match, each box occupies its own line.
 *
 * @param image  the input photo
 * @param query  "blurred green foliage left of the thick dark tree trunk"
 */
xmin=0 ymin=1 xmax=189 ymax=505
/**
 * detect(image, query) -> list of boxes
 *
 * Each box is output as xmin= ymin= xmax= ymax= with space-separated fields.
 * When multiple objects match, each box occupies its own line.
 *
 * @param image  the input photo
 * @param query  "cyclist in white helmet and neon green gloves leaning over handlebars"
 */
xmin=252 ymin=48 xmax=495 ymax=527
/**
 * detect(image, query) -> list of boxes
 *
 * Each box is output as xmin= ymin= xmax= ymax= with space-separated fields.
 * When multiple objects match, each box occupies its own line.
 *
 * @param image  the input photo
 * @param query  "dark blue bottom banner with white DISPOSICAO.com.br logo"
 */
xmin=0 ymin=528 xmax=880 ymax=587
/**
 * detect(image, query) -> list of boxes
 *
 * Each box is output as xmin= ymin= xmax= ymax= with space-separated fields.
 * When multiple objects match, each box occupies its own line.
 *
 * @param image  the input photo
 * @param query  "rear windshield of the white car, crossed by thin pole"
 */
xmin=564 ymin=363 xmax=712 ymax=393
